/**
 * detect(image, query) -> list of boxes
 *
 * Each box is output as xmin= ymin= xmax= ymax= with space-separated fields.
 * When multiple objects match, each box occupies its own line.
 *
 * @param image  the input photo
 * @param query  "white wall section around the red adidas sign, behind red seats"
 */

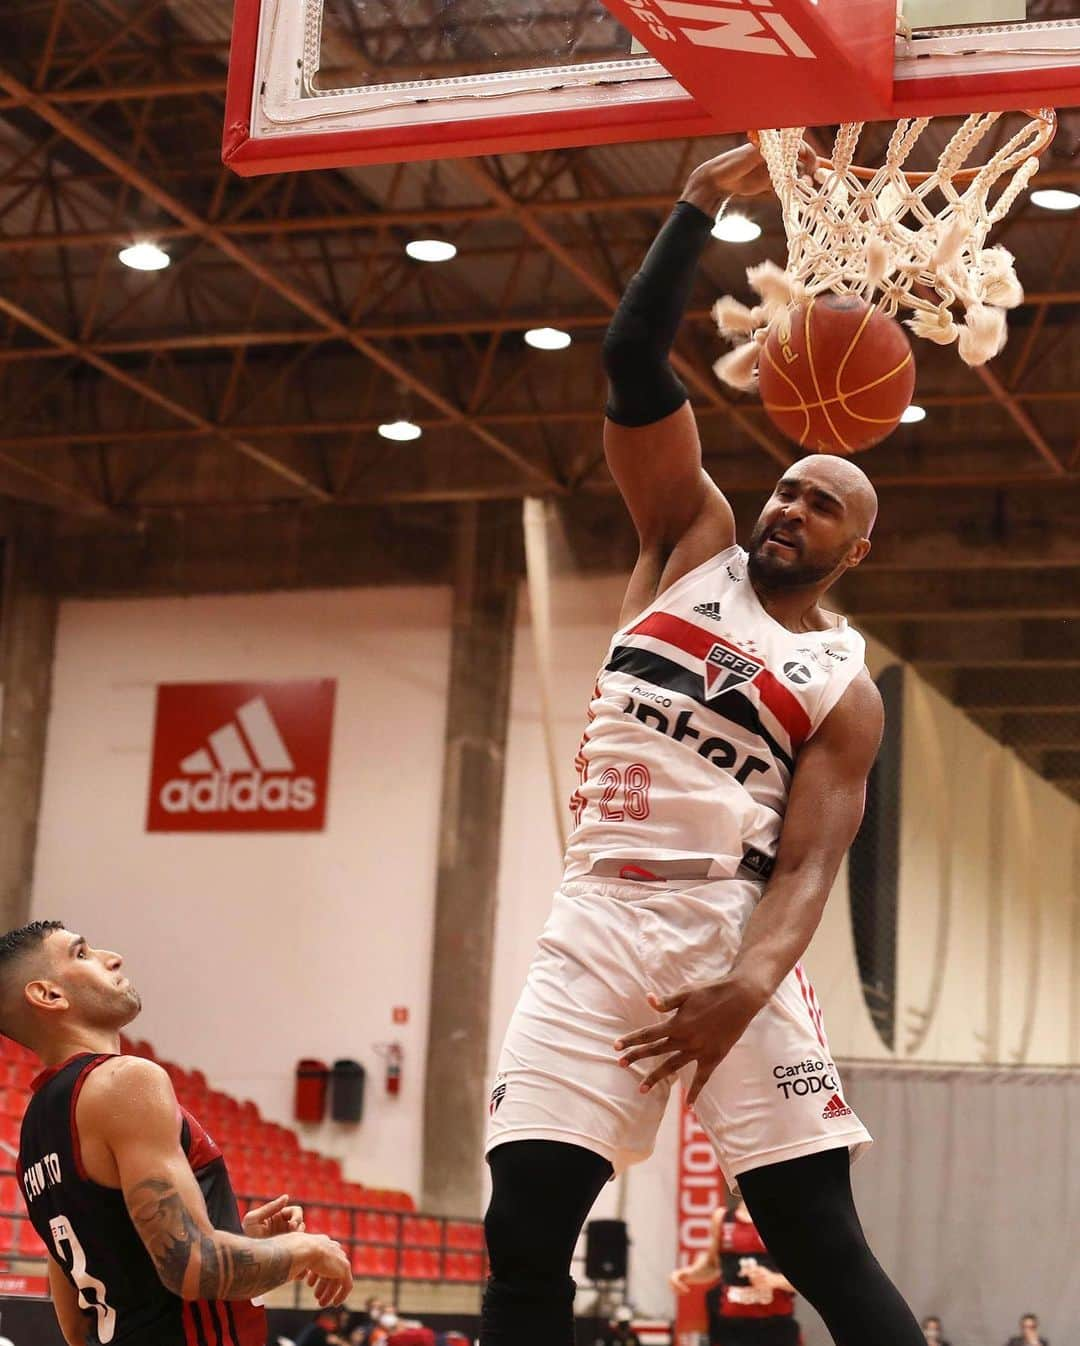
xmin=34 ymin=588 xmax=450 ymax=1191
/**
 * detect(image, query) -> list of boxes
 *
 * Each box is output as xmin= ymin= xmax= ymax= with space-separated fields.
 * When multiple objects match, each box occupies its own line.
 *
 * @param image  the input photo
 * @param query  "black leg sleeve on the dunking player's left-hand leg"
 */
xmin=481 ymin=1140 xmax=611 ymax=1346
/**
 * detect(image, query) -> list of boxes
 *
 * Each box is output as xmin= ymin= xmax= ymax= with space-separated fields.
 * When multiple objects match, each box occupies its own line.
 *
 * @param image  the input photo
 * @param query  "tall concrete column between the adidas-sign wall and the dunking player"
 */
xmin=421 ymin=502 xmax=521 ymax=1217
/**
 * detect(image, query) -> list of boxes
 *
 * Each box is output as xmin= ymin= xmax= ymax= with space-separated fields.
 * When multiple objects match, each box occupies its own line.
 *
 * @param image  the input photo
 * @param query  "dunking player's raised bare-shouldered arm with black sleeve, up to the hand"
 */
xmin=603 ymin=144 xmax=769 ymax=611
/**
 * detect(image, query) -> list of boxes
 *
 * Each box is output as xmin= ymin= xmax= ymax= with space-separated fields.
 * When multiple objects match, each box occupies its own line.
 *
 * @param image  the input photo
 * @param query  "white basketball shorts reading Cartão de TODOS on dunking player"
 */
xmin=487 ymin=878 xmax=870 ymax=1190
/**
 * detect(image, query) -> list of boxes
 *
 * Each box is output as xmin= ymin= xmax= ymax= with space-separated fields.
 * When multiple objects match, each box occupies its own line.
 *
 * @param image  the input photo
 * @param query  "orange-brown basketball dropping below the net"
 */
xmin=758 ymin=295 xmax=914 ymax=454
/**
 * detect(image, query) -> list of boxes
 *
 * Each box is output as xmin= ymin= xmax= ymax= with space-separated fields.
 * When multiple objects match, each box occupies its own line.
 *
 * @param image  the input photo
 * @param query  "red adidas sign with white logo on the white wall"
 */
xmin=147 ymin=678 xmax=335 ymax=832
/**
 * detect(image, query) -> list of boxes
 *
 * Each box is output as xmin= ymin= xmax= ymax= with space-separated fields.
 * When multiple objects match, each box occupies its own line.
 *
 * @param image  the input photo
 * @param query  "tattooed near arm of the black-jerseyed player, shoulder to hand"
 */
xmin=78 ymin=1057 xmax=353 ymax=1304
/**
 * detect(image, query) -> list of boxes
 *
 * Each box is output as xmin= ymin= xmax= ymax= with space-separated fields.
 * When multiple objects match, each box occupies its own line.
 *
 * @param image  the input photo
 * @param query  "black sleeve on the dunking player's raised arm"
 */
xmin=603 ymin=201 xmax=714 ymax=425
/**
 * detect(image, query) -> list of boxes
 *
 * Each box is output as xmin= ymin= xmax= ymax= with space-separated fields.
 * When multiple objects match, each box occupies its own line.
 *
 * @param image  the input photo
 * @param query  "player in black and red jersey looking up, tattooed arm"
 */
xmin=0 ymin=921 xmax=353 ymax=1346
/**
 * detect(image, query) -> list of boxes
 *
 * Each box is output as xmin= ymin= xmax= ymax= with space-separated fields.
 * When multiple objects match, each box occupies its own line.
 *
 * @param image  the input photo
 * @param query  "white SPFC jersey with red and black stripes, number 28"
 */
xmin=566 ymin=546 xmax=866 ymax=879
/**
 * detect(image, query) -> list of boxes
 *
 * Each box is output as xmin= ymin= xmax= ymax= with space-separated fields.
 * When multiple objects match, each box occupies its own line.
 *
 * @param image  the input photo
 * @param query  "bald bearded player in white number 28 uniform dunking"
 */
xmin=481 ymin=145 xmax=922 ymax=1346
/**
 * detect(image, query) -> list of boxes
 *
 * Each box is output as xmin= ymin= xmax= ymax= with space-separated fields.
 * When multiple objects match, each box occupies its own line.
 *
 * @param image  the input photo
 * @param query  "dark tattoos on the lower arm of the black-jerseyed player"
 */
xmin=128 ymin=1178 xmax=292 ymax=1299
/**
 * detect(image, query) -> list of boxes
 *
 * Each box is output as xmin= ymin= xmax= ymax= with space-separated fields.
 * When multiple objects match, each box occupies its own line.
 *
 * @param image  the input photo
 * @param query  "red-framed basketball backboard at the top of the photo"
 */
xmin=222 ymin=0 xmax=1080 ymax=174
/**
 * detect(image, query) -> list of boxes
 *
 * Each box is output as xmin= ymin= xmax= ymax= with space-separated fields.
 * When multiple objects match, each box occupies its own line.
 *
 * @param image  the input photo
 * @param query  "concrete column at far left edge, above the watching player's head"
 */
xmin=0 ymin=506 xmax=57 ymax=930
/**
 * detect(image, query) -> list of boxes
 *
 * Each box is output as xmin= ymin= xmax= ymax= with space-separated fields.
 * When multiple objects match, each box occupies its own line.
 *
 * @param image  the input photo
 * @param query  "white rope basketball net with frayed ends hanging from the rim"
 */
xmin=714 ymin=110 xmax=1056 ymax=388
